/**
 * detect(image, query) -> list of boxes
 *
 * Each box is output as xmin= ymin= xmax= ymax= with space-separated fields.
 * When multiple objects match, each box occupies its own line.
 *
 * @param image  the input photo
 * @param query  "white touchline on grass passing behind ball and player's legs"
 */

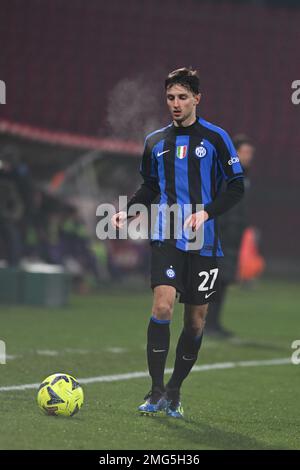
xmin=0 ymin=358 xmax=292 ymax=392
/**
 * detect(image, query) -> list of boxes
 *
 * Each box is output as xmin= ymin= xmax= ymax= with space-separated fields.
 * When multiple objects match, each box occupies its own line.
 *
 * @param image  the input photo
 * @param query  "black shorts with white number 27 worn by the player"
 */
xmin=151 ymin=242 xmax=219 ymax=305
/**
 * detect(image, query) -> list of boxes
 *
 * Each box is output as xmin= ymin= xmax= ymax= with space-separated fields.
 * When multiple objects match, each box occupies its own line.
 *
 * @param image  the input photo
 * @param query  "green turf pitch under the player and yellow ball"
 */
xmin=0 ymin=281 xmax=300 ymax=450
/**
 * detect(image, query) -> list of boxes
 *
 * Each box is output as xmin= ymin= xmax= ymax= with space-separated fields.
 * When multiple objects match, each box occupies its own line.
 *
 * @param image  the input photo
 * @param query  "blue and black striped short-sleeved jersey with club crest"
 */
xmin=140 ymin=117 xmax=243 ymax=256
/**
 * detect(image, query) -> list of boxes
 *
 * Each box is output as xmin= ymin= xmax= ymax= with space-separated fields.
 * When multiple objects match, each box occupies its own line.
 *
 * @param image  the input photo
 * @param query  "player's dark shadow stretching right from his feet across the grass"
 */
xmin=155 ymin=417 xmax=288 ymax=450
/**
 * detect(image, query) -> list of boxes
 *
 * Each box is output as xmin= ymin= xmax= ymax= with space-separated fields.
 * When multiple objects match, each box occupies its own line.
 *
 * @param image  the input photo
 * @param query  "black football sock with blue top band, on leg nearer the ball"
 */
xmin=147 ymin=317 xmax=170 ymax=391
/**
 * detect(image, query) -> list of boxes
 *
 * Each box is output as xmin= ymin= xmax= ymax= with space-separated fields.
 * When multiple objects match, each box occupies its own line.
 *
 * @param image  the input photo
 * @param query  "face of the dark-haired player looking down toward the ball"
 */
xmin=166 ymin=85 xmax=201 ymax=126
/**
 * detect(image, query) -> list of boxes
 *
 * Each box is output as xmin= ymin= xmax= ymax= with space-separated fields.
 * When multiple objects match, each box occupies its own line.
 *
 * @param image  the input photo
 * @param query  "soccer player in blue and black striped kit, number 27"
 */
xmin=112 ymin=68 xmax=244 ymax=418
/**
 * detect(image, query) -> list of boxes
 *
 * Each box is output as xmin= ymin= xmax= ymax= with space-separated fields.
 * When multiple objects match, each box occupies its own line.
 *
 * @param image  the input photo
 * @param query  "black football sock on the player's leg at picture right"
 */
xmin=167 ymin=329 xmax=203 ymax=390
